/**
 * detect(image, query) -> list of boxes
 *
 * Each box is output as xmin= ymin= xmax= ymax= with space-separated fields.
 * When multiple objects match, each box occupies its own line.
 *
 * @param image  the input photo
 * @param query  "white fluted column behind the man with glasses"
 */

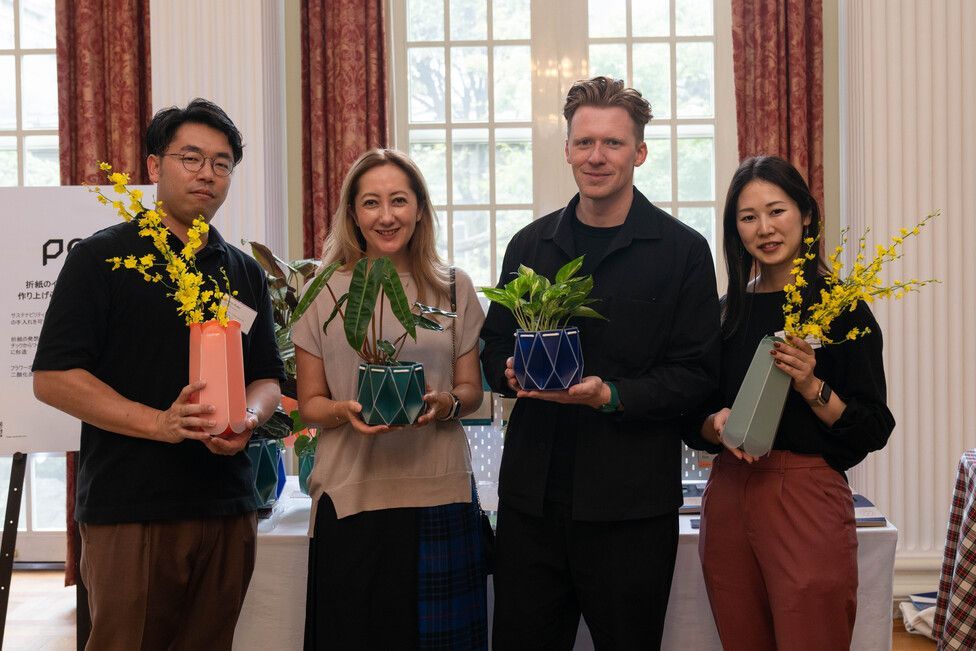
xmin=150 ymin=0 xmax=287 ymax=257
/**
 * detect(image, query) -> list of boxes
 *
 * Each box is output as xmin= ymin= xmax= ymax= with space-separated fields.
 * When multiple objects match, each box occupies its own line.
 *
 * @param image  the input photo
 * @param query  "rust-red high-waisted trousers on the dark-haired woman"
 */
xmin=698 ymin=450 xmax=857 ymax=651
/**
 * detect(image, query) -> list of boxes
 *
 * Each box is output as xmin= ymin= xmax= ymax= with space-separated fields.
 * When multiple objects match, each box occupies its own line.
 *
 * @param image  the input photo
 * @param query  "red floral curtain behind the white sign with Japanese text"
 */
xmin=55 ymin=0 xmax=152 ymax=585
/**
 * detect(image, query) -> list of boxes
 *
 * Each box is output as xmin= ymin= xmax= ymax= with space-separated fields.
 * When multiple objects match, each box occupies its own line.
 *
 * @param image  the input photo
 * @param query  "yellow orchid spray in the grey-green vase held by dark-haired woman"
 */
xmin=783 ymin=210 xmax=941 ymax=344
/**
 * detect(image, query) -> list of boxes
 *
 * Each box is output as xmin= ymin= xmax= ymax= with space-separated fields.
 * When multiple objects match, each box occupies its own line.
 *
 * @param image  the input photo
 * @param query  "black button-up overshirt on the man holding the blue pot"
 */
xmin=481 ymin=189 xmax=720 ymax=521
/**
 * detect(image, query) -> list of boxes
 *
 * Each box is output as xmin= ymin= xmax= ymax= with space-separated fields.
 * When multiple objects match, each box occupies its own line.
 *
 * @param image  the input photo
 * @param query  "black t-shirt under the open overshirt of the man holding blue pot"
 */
xmin=546 ymin=218 xmax=622 ymax=504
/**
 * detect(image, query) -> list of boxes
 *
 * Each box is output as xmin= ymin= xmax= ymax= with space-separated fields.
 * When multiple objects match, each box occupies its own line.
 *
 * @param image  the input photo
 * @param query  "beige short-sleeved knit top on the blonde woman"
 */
xmin=292 ymin=269 xmax=485 ymax=536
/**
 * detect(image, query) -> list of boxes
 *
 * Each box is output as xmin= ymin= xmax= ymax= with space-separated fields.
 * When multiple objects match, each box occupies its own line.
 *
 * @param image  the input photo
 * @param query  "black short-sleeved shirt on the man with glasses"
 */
xmin=33 ymin=222 xmax=284 ymax=524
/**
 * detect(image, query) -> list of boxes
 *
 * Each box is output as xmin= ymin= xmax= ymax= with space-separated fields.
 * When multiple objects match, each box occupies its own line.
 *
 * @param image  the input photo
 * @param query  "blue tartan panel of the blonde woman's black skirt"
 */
xmin=417 ymin=486 xmax=488 ymax=649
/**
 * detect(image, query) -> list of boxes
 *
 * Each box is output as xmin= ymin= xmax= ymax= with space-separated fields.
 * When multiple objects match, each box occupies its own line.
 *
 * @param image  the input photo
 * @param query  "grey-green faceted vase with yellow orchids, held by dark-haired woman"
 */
xmin=722 ymin=211 xmax=940 ymax=457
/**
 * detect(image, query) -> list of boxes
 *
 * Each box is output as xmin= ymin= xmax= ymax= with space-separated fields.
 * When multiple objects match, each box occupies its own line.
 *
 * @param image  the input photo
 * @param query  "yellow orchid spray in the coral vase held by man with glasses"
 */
xmin=91 ymin=162 xmax=237 ymax=326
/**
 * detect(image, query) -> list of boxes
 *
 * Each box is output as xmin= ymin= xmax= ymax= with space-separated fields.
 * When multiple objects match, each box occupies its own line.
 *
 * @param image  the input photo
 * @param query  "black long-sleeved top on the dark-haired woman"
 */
xmin=689 ymin=291 xmax=895 ymax=472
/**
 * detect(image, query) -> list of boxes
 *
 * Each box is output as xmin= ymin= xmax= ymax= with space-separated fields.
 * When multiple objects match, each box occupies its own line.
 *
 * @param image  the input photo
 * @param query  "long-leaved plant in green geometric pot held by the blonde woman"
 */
xmin=316 ymin=257 xmax=456 ymax=425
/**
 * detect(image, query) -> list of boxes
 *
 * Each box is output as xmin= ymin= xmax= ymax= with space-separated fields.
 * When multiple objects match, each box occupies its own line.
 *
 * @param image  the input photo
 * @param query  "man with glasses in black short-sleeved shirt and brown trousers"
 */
xmin=33 ymin=99 xmax=284 ymax=650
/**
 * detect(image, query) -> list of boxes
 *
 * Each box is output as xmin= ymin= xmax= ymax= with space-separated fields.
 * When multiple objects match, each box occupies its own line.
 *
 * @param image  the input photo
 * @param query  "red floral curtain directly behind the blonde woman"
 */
xmin=302 ymin=0 xmax=388 ymax=257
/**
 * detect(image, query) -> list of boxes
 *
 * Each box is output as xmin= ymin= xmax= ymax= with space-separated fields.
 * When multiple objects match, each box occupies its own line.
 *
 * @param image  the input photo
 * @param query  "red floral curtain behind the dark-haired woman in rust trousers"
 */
xmin=732 ymin=0 xmax=823 ymax=211
